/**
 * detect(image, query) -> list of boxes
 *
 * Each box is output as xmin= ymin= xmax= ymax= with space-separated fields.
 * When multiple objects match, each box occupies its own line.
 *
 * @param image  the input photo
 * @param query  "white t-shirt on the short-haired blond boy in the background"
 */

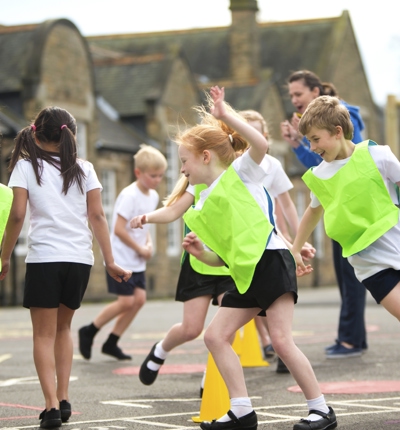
xmin=111 ymin=182 xmax=159 ymax=272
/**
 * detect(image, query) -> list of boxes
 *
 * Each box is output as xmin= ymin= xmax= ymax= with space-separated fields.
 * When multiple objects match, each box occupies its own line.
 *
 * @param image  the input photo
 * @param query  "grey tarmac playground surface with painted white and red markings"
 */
xmin=0 ymin=287 xmax=400 ymax=430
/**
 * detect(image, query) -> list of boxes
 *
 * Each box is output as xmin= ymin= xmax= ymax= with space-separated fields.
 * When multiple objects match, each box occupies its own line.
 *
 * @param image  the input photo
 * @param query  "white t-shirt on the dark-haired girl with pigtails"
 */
xmin=8 ymin=160 xmax=102 ymax=265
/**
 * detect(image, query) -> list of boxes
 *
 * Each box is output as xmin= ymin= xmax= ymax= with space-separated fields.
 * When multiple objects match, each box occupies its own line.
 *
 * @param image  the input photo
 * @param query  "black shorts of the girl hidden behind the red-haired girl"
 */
xmin=175 ymin=255 xmax=236 ymax=304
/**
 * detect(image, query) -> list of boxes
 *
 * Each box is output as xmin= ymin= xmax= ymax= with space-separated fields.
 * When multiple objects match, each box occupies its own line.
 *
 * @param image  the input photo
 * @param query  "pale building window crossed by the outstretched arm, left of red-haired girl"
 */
xmin=165 ymin=140 xmax=182 ymax=257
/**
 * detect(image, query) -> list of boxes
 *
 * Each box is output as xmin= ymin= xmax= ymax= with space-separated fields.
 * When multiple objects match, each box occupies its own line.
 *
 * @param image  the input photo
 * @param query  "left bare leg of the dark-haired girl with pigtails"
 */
xmin=30 ymin=307 xmax=59 ymax=410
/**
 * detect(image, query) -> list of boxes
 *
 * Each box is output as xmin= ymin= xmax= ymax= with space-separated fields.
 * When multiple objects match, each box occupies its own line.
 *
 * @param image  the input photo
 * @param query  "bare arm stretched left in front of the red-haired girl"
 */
xmin=130 ymin=191 xmax=194 ymax=228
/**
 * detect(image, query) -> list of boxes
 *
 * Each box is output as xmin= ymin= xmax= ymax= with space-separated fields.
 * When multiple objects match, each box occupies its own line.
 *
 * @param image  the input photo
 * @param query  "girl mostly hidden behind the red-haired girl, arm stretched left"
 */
xmin=131 ymin=109 xmax=247 ymax=388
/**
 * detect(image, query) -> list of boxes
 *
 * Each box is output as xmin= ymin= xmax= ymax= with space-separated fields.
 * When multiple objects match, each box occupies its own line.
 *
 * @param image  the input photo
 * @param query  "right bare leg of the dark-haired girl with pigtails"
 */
xmin=54 ymin=304 xmax=75 ymax=402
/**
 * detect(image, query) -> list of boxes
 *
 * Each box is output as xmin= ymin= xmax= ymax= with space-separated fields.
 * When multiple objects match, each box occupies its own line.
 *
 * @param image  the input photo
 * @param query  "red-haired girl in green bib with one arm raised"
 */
xmin=178 ymin=87 xmax=337 ymax=430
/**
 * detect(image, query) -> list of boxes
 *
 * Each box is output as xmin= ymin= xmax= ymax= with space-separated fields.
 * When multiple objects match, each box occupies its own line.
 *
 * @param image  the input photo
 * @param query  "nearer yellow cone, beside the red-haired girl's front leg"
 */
xmin=192 ymin=353 xmax=230 ymax=423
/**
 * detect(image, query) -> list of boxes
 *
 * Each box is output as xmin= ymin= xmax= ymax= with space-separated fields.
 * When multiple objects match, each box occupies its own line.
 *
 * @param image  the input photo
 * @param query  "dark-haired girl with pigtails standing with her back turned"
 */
xmin=0 ymin=107 xmax=131 ymax=428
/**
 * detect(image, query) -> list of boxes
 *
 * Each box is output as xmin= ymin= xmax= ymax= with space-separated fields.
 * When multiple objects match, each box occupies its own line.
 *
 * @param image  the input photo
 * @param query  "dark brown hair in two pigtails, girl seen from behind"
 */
xmin=8 ymin=107 xmax=85 ymax=194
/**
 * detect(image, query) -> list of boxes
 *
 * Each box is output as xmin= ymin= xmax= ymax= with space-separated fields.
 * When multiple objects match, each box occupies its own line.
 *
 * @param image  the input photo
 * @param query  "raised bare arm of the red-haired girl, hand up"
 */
xmin=210 ymin=86 xmax=268 ymax=164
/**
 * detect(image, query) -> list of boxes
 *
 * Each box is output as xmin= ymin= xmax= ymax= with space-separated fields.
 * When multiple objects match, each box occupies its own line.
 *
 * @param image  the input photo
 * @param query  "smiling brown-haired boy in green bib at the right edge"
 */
xmin=293 ymin=96 xmax=400 ymax=344
